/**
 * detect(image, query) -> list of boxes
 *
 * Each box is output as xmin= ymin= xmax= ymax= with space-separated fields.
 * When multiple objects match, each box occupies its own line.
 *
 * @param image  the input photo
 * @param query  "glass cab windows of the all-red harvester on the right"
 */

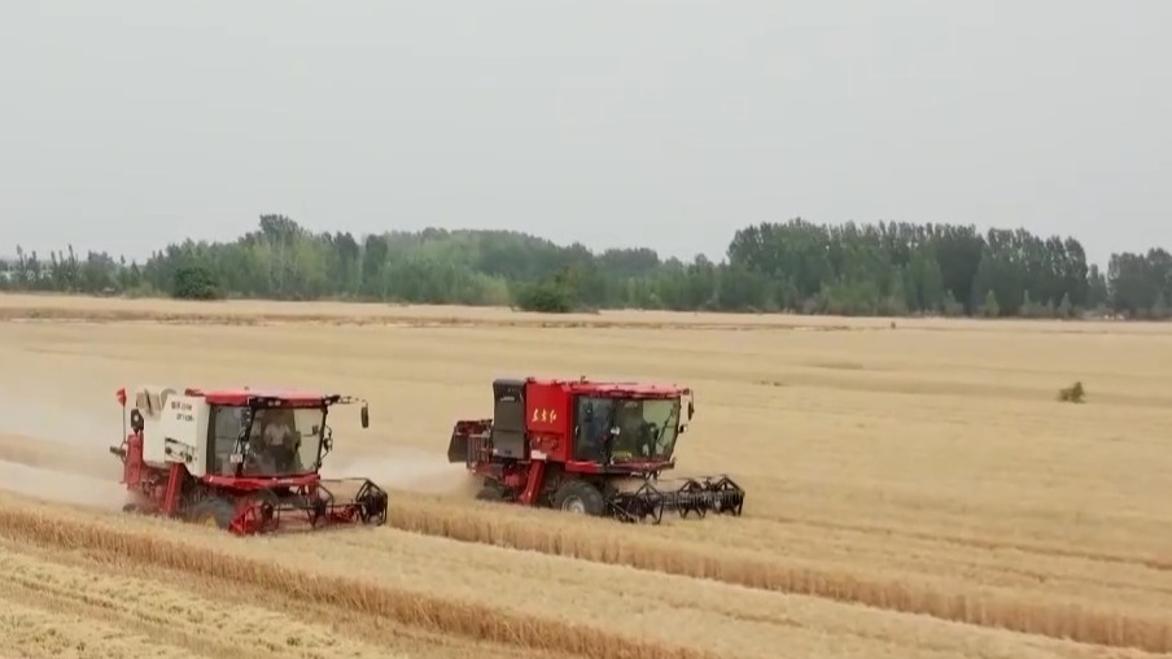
xmin=574 ymin=396 xmax=680 ymax=462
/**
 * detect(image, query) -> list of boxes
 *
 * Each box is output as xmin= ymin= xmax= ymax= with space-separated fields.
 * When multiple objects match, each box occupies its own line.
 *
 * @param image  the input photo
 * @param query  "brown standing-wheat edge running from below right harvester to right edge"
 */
xmin=390 ymin=496 xmax=1172 ymax=652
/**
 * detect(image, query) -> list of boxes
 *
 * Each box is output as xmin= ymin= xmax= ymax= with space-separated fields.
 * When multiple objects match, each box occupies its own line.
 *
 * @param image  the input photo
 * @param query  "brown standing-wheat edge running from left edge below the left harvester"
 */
xmin=0 ymin=509 xmax=706 ymax=659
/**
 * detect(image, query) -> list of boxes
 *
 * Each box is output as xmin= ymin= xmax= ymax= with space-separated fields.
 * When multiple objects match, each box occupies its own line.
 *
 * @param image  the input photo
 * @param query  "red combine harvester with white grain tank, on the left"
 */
xmin=110 ymin=387 xmax=387 ymax=535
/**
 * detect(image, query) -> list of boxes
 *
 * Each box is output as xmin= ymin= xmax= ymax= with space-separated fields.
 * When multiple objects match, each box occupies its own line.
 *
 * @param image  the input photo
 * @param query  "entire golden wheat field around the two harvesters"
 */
xmin=0 ymin=295 xmax=1172 ymax=658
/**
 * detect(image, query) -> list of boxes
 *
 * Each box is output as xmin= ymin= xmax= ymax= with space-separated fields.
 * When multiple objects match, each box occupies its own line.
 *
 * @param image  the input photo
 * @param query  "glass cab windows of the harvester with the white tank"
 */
xmin=207 ymin=407 xmax=326 ymax=476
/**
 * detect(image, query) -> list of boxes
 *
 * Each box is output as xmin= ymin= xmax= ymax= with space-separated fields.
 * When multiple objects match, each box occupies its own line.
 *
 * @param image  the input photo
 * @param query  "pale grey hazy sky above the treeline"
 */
xmin=0 ymin=0 xmax=1172 ymax=263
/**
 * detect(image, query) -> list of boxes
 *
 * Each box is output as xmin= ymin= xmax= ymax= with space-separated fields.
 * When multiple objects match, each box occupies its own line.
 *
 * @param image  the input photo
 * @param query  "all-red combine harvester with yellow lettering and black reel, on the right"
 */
xmin=448 ymin=378 xmax=744 ymax=523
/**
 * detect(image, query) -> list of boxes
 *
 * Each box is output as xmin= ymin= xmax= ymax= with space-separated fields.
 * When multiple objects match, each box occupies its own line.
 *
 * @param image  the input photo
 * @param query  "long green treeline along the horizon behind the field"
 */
xmin=0 ymin=215 xmax=1172 ymax=319
